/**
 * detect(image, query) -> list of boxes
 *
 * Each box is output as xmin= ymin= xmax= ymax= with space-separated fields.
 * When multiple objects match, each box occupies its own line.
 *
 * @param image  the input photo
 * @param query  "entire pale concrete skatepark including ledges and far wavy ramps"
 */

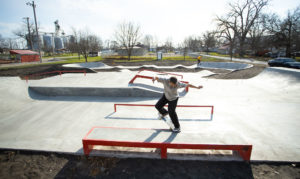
xmin=0 ymin=63 xmax=300 ymax=162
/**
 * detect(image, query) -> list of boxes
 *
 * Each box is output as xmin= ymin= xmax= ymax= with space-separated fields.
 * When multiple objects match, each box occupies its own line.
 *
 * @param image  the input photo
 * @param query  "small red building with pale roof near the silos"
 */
xmin=9 ymin=50 xmax=40 ymax=63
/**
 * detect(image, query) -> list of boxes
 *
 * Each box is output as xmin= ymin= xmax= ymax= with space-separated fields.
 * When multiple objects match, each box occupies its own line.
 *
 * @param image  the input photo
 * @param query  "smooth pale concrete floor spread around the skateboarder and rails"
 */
xmin=0 ymin=65 xmax=300 ymax=161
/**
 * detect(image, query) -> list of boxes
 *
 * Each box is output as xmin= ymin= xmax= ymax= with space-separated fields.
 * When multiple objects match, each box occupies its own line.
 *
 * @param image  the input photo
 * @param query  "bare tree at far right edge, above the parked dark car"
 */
xmin=264 ymin=6 xmax=300 ymax=57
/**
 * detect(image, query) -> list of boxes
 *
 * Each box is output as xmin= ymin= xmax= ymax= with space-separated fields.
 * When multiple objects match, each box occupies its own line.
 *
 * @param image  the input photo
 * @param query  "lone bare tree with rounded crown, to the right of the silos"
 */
xmin=114 ymin=22 xmax=141 ymax=60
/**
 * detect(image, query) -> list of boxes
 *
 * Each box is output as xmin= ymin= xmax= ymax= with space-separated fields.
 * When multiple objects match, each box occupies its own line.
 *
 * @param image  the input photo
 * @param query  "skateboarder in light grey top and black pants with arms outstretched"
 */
xmin=152 ymin=77 xmax=203 ymax=132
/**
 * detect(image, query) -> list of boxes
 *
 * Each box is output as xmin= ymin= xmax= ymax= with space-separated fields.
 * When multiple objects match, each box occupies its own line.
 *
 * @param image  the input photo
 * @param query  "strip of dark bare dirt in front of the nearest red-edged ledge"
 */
xmin=0 ymin=151 xmax=300 ymax=179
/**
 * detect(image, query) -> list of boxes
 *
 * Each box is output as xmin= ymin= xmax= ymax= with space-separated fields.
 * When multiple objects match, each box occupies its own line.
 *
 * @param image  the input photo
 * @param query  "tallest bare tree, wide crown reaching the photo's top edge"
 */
xmin=217 ymin=0 xmax=269 ymax=56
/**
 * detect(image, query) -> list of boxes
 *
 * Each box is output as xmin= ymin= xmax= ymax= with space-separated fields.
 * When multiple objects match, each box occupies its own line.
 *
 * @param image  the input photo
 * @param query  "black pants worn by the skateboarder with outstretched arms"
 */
xmin=155 ymin=94 xmax=180 ymax=128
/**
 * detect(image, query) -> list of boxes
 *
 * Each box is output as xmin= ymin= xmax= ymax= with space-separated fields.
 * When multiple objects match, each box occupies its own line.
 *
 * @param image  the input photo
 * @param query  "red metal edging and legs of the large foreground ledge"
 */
xmin=82 ymin=127 xmax=252 ymax=161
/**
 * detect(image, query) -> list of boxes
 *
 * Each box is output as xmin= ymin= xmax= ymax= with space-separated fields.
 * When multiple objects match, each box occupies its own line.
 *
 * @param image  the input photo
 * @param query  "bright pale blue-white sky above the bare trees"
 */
xmin=0 ymin=0 xmax=300 ymax=43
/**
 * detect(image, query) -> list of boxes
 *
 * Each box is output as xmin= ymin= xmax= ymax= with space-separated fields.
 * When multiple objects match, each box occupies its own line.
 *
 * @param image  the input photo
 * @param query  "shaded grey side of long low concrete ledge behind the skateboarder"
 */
xmin=29 ymin=86 xmax=162 ymax=98
